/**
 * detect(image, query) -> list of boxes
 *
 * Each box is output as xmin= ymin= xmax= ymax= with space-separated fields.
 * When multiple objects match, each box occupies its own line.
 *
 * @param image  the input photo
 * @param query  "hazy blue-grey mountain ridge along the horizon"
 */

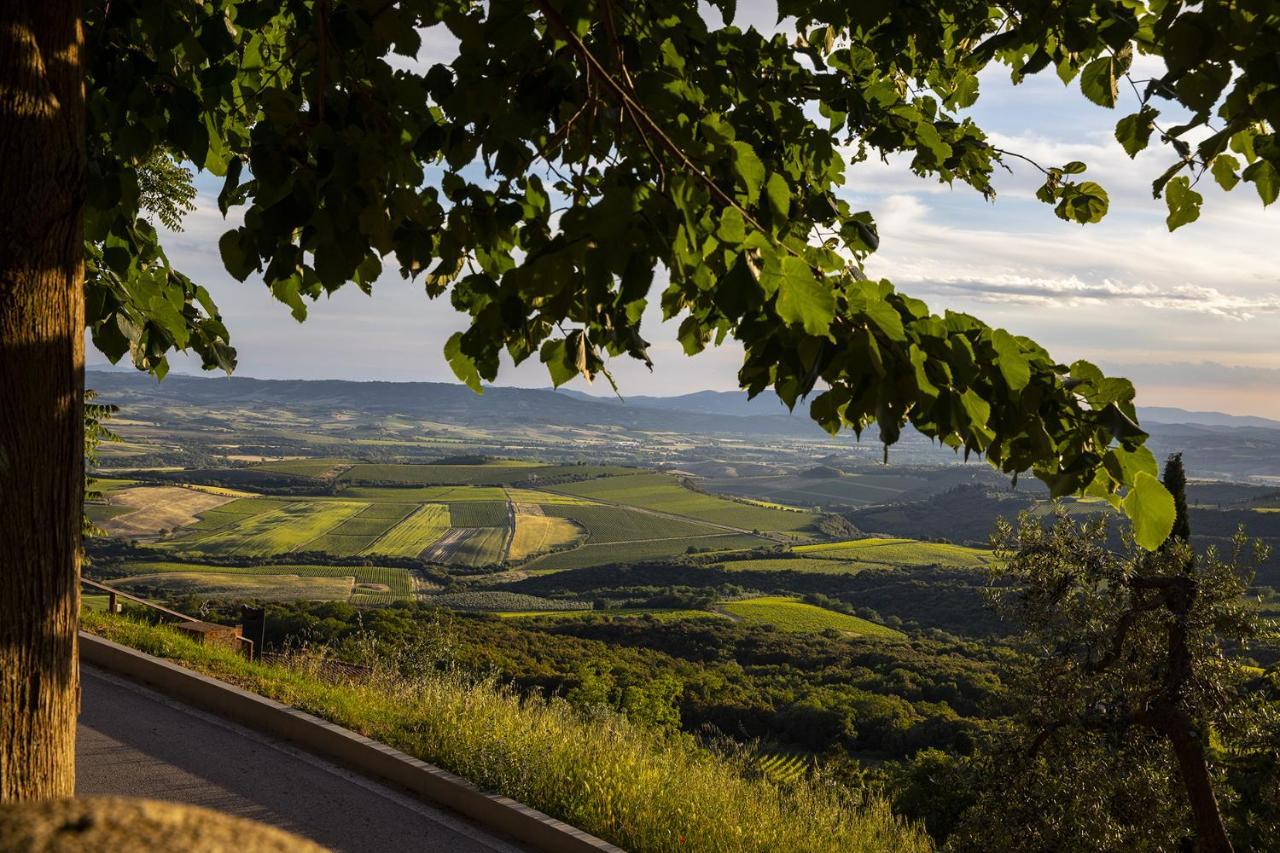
xmin=86 ymin=370 xmax=1280 ymax=483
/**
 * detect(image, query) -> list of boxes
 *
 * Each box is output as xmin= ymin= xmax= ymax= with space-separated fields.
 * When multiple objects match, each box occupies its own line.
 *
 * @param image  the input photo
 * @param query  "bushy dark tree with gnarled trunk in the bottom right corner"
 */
xmin=954 ymin=504 xmax=1280 ymax=850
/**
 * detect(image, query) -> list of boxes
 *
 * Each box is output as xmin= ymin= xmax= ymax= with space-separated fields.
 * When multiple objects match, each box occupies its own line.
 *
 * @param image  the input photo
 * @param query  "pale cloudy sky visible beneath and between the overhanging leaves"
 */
xmin=88 ymin=1 xmax=1280 ymax=418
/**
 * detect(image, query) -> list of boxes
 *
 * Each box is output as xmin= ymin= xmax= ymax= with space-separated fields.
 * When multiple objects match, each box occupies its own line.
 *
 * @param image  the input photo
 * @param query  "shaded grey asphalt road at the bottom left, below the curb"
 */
xmin=76 ymin=666 xmax=522 ymax=853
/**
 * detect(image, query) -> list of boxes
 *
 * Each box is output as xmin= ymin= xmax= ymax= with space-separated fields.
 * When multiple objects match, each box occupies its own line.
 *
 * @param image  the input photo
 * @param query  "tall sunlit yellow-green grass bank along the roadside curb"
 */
xmin=82 ymin=612 xmax=931 ymax=853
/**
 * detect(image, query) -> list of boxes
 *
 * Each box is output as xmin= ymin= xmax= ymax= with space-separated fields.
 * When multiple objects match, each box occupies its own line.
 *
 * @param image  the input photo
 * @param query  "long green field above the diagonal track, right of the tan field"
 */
xmin=553 ymin=474 xmax=817 ymax=533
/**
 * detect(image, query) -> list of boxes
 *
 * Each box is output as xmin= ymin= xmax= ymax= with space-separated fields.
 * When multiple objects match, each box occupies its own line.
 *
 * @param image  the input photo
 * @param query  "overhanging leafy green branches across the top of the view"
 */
xmin=86 ymin=0 xmax=1280 ymax=547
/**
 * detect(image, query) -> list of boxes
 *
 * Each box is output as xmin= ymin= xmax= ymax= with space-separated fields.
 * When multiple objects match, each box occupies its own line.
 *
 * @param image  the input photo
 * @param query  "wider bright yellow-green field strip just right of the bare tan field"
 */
xmin=182 ymin=501 xmax=366 ymax=556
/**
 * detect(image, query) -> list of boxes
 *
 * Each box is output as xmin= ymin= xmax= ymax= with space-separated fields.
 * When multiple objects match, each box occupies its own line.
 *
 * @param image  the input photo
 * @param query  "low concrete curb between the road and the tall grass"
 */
xmin=79 ymin=631 xmax=622 ymax=853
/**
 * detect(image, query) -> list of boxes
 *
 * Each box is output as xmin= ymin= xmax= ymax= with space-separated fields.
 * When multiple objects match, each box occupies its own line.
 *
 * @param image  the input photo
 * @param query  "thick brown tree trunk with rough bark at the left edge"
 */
xmin=0 ymin=0 xmax=84 ymax=802
